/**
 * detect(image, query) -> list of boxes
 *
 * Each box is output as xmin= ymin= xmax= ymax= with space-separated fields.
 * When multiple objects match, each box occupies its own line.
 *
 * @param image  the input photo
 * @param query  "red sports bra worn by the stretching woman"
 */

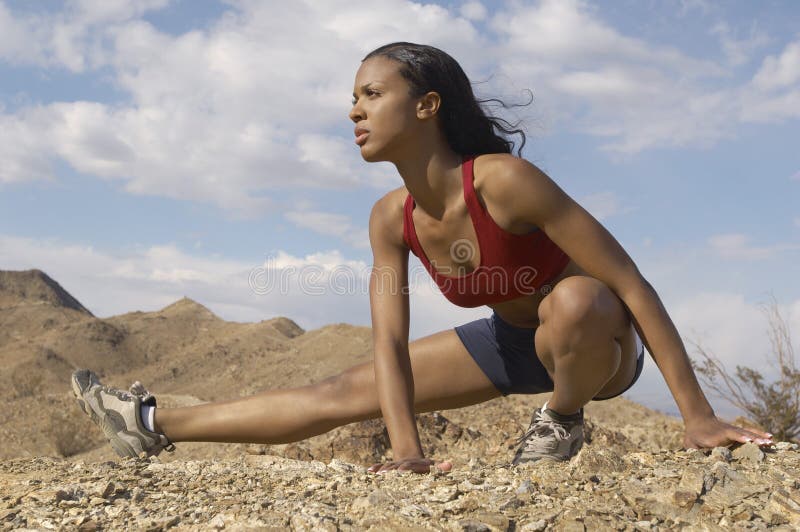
xmin=403 ymin=159 xmax=570 ymax=307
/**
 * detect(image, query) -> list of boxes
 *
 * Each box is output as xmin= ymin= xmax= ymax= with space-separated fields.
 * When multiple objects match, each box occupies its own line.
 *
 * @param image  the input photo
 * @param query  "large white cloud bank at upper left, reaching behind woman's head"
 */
xmin=0 ymin=0 xmax=481 ymax=212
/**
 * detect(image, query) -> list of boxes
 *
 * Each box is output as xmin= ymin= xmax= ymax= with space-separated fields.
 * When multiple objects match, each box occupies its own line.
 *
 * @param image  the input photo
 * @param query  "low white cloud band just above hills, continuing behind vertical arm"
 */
xmin=0 ymin=235 xmax=487 ymax=339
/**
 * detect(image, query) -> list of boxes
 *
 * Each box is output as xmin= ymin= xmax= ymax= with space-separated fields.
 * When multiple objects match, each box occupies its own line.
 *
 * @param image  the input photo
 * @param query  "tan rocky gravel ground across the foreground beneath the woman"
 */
xmin=0 ymin=444 xmax=800 ymax=531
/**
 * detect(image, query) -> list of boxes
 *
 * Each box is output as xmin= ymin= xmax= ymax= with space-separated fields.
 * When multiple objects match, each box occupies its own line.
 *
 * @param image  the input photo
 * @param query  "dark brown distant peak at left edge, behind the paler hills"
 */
xmin=0 ymin=269 xmax=94 ymax=316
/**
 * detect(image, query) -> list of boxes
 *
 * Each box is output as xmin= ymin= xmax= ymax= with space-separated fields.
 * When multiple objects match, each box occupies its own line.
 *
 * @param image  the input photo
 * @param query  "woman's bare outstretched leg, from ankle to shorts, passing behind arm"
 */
xmin=155 ymin=329 xmax=501 ymax=444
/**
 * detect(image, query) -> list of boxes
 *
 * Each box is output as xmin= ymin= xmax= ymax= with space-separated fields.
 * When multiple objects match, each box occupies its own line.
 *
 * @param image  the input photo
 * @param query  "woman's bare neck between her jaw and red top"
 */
xmin=394 ymin=146 xmax=463 ymax=220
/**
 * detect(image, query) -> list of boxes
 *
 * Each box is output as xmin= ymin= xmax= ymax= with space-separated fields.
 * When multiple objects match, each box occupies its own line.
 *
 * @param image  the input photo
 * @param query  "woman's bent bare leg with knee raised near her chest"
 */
xmin=535 ymin=276 xmax=637 ymax=415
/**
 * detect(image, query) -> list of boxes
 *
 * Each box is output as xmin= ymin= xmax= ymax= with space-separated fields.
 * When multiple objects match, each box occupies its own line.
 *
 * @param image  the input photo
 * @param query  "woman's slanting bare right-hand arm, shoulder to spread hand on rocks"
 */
xmin=494 ymin=157 xmax=776 ymax=446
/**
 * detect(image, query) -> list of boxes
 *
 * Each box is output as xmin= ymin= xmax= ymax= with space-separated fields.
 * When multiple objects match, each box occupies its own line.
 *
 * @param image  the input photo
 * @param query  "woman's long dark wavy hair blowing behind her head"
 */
xmin=362 ymin=42 xmax=532 ymax=156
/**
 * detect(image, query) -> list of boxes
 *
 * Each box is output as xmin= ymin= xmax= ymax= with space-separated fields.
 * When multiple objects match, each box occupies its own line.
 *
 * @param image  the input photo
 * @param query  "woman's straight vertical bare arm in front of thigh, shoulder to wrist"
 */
xmin=369 ymin=193 xmax=423 ymax=461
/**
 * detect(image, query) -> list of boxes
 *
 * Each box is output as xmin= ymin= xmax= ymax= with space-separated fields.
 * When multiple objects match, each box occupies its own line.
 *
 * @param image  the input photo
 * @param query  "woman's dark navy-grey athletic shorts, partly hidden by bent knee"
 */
xmin=455 ymin=312 xmax=644 ymax=401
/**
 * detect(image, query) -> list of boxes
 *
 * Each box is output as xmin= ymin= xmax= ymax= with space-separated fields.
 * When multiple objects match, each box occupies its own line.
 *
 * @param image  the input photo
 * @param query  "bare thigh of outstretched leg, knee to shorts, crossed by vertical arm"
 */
xmin=337 ymin=329 xmax=501 ymax=421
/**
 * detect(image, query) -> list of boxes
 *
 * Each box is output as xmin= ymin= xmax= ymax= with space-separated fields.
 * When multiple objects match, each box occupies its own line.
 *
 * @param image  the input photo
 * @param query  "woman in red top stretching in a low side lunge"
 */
xmin=72 ymin=43 xmax=771 ymax=473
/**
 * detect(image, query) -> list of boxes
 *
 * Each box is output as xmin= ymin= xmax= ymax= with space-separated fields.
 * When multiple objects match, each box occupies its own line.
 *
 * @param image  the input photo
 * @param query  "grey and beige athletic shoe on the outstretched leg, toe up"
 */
xmin=72 ymin=369 xmax=175 ymax=458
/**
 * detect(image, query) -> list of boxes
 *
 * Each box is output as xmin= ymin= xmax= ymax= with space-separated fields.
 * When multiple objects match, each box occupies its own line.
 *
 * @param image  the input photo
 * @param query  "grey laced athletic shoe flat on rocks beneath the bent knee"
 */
xmin=511 ymin=403 xmax=583 ymax=465
